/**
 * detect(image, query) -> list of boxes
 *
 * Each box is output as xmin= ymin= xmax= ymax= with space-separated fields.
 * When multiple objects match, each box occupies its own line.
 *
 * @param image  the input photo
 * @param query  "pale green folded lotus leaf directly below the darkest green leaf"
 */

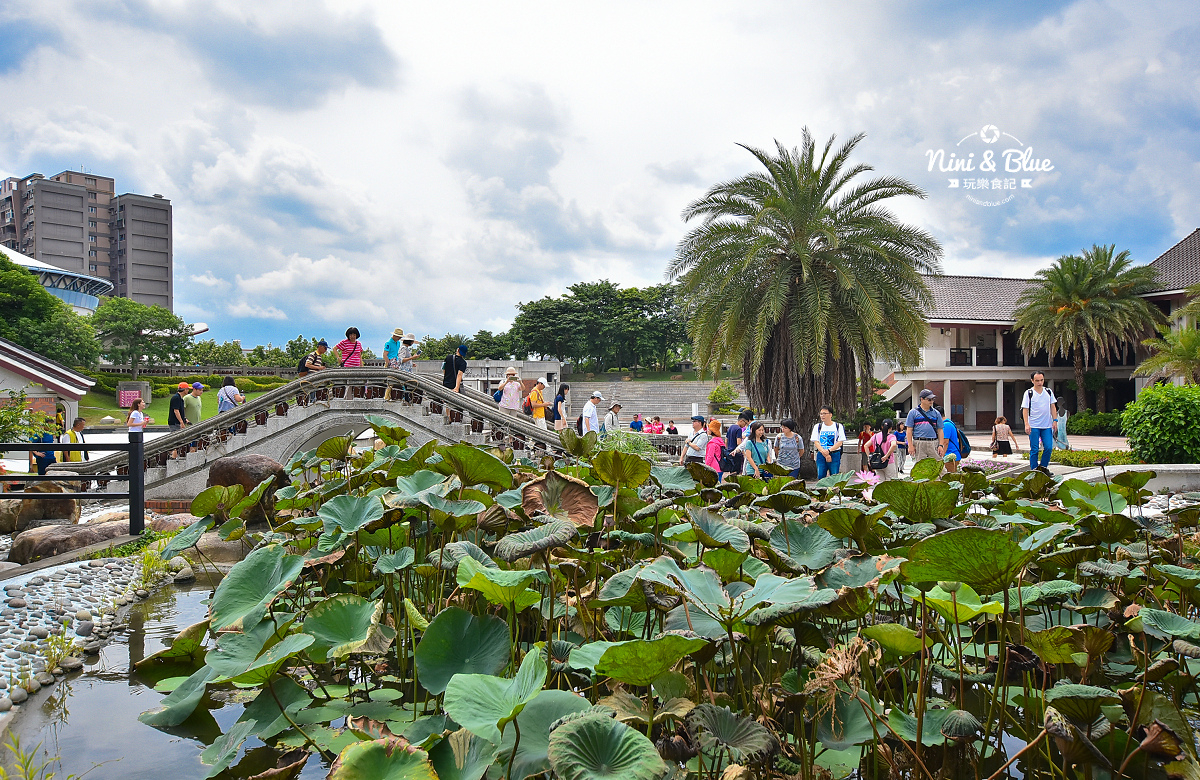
xmin=443 ymin=653 xmax=546 ymax=745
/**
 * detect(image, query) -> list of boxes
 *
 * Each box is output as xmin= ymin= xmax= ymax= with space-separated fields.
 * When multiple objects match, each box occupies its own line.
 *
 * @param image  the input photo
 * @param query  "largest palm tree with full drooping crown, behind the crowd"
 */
xmin=668 ymin=128 xmax=942 ymax=420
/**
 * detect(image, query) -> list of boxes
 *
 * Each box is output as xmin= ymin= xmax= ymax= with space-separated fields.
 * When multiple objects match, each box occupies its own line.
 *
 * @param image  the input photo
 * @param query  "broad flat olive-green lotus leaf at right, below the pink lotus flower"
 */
xmin=902 ymin=525 xmax=1037 ymax=594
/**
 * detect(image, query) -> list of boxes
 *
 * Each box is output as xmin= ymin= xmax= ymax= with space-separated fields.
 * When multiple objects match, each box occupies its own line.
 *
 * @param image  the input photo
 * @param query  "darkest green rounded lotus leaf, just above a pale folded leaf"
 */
xmin=414 ymin=607 xmax=511 ymax=695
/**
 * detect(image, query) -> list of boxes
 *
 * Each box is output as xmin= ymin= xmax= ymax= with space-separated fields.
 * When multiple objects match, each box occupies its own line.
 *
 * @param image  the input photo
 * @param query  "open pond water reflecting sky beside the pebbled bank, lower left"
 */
xmin=16 ymin=571 xmax=328 ymax=780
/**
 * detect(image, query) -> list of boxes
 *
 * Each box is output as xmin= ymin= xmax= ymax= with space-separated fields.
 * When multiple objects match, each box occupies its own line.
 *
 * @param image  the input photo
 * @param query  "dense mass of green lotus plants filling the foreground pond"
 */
xmin=72 ymin=420 xmax=1200 ymax=780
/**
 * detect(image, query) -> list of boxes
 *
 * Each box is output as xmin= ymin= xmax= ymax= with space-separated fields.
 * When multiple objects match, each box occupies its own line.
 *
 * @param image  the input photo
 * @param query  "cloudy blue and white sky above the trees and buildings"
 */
xmin=0 ymin=0 xmax=1200 ymax=350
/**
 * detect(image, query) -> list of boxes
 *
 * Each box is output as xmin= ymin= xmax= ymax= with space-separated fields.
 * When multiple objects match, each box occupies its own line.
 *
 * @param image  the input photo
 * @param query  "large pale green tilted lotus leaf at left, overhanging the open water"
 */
xmin=209 ymin=545 xmax=304 ymax=631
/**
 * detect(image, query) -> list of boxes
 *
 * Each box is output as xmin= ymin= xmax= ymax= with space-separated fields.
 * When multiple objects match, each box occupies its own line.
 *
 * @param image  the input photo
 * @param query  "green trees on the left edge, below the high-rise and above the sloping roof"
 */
xmin=0 ymin=252 xmax=100 ymax=367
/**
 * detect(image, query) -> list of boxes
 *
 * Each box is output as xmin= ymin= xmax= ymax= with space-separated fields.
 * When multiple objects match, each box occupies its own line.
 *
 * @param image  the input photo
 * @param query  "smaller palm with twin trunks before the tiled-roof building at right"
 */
xmin=1016 ymin=245 xmax=1162 ymax=412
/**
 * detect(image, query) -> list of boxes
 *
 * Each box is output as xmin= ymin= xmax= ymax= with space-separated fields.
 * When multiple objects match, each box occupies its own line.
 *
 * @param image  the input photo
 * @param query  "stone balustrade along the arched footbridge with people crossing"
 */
xmin=50 ymin=368 xmax=562 ymax=474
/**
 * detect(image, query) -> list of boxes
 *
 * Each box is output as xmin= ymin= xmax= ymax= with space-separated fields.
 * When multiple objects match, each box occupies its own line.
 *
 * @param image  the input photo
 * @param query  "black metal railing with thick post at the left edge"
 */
xmin=0 ymin=431 xmax=146 ymax=536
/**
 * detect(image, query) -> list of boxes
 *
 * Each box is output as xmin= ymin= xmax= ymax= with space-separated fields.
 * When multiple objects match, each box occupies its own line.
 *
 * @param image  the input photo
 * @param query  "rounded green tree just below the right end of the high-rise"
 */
xmin=91 ymin=298 xmax=192 ymax=379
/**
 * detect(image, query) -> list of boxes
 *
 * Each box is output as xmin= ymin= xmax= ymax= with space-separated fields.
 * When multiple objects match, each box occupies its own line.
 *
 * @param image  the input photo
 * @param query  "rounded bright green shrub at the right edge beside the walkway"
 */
xmin=1121 ymin=384 xmax=1200 ymax=463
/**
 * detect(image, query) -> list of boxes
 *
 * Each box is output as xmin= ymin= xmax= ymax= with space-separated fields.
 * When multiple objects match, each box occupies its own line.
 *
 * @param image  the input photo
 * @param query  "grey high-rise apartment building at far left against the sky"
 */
xmin=0 ymin=170 xmax=174 ymax=310
